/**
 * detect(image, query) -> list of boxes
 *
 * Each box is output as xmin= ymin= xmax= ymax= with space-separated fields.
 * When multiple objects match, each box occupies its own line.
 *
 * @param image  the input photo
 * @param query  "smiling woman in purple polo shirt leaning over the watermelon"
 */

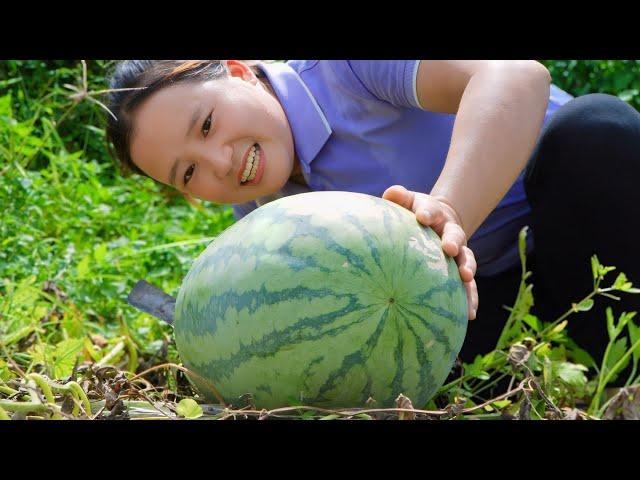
xmin=108 ymin=60 xmax=640 ymax=368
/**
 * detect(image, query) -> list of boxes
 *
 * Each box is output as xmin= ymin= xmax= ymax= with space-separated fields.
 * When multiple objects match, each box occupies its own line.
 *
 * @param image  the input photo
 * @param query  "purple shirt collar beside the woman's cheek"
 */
xmin=259 ymin=62 xmax=332 ymax=174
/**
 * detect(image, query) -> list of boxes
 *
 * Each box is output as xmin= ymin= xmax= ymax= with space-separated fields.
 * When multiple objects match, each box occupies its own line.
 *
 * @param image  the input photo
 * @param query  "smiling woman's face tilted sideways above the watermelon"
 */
xmin=131 ymin=60 xmax=295 ymax=204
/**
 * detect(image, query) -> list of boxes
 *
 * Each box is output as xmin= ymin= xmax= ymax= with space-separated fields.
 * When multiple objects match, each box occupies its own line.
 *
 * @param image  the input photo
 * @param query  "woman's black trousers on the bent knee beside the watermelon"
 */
xmin=460 ymin=94 xmax=640 ymax=382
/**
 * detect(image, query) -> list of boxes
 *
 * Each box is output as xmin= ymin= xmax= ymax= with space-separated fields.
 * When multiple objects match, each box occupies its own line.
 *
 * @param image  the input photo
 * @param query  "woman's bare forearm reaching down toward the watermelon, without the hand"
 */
xmin=430 ymin=64 xmax=550 ymax=238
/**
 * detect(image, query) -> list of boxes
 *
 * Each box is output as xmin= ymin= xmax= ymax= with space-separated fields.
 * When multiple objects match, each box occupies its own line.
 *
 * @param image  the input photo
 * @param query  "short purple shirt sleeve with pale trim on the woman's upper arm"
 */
xmin=348 ymin=60 xmax=422 ymax=108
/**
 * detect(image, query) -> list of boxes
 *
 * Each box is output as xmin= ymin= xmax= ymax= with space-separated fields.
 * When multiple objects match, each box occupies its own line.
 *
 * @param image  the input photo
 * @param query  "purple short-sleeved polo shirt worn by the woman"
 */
xmin=233 ymin=60 xmax=573 ymax=276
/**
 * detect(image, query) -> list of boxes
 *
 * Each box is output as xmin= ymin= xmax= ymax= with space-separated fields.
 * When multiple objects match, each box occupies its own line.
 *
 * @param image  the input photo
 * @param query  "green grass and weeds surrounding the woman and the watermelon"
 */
xmin=0 ymin=61 xmax=640 ymax=419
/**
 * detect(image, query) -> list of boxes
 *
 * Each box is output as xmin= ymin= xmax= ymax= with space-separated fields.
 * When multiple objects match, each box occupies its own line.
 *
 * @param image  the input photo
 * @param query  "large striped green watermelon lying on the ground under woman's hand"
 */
xmin=175 ymin=192 xmax=467 ymax=408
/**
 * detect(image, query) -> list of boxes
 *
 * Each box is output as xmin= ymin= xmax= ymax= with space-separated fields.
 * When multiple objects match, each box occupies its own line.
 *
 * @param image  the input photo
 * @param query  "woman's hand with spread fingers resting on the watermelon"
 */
xmin=382 ymin=185 xmax=478 ymax=320
